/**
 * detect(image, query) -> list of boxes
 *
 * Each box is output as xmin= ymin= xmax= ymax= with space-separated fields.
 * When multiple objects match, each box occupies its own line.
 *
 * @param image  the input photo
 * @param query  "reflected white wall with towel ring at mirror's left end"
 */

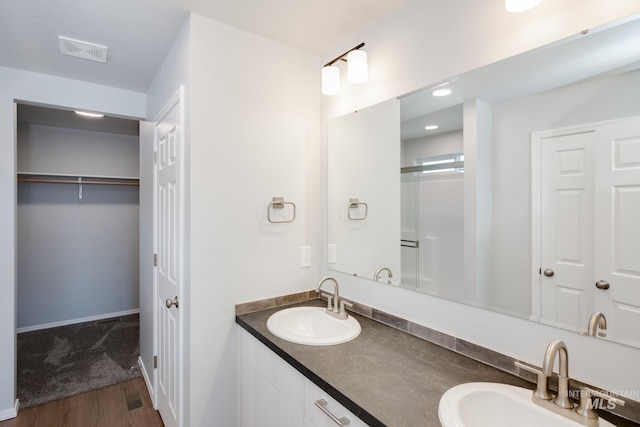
xmin=328 ymin=99 xmax=400 ymax=284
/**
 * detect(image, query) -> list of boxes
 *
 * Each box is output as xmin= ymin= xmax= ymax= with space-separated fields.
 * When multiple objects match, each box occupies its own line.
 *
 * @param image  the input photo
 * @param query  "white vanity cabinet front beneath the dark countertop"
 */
xmin=239 ymin=328 xmax=367 ymax=427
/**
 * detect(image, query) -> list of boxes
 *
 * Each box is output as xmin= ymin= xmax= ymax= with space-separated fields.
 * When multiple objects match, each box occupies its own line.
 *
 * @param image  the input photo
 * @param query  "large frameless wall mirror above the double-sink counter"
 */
xmin=328 ymin=16 xmax=640 ymax=347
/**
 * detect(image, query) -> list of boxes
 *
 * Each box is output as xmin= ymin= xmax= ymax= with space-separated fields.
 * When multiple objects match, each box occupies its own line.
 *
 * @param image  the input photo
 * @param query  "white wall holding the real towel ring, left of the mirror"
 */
xmin=145 ymin=15 xmax=325 ymax=426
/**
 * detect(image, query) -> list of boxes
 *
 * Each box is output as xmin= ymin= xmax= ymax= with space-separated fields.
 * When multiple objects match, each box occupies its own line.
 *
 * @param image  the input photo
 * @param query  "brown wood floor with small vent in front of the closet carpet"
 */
xmin=0 ymin=378 xmax=164 ymax=427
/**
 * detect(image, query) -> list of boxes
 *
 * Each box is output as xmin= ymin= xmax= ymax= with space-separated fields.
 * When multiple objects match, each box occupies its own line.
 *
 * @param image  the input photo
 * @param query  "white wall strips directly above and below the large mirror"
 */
xmin=323 ymin=0 xmax=640 ymax=400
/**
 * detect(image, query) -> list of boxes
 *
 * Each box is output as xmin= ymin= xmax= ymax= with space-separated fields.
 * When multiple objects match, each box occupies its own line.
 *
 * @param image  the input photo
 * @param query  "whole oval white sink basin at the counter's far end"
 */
xmin=267 ymin=307 xmax=360 ymax=345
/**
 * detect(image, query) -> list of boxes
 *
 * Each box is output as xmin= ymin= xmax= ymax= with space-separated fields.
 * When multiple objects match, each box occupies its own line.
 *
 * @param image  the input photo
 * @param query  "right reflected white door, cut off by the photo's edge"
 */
xmin=590 ymin=118 xmax=640 ymax=344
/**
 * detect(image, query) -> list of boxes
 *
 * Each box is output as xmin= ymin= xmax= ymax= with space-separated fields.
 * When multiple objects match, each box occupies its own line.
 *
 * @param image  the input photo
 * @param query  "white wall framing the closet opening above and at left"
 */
xmin=0 ymin=67 xmax=146 ymax=419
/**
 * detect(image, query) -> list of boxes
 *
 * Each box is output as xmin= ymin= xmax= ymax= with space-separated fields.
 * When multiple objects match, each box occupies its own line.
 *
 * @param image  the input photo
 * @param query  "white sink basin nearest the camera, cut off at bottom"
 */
xmin=438 ymin=383 xmax=615 ymax=427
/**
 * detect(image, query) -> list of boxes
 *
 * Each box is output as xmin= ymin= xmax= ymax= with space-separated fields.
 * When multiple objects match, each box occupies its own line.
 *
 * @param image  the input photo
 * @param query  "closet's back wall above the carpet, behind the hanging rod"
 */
xmin=17 ymin=123 xmax=139 ymax=330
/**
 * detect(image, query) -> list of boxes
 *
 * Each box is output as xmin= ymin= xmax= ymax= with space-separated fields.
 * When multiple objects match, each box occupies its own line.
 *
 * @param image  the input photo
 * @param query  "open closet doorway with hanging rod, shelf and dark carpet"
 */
xmin=16 ymin=104 xmax=140 ymax=408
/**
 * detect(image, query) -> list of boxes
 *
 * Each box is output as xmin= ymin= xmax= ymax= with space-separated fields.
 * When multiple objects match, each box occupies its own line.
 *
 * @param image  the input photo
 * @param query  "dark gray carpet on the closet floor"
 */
xmin=18 ymin=314 xmax=141 ymax=409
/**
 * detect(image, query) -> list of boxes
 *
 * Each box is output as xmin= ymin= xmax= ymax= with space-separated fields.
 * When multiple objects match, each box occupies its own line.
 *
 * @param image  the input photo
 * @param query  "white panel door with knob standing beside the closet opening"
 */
xmin=154 ymin=87 xmax=184 ymax=427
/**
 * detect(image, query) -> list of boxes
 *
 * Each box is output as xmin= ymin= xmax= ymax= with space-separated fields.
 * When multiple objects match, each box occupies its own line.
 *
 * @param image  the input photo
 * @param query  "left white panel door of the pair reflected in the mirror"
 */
xmin=540 ymin=131 xmax=595 ymax=329
